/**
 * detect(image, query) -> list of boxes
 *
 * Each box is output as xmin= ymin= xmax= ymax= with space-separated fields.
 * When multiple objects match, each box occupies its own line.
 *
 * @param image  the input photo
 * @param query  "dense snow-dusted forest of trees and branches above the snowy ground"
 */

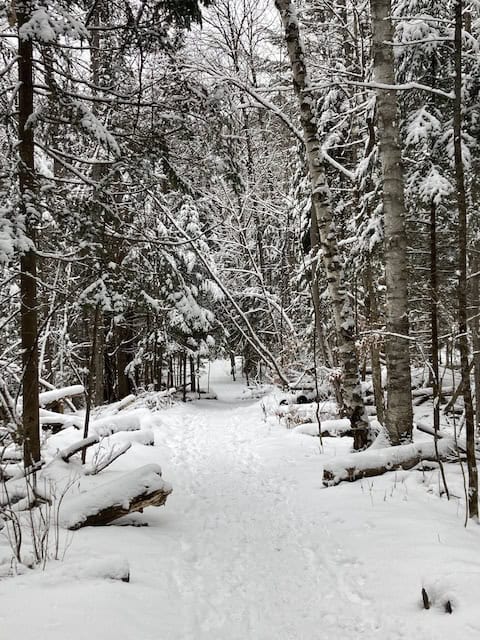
xmin=0 ymin=0 xmax=480 ymax=517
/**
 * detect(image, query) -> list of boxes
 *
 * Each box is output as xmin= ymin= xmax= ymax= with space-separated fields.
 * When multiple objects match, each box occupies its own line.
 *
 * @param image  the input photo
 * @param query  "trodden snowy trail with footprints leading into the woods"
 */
xmin=152 ymin=382 xmax=372 ymax=640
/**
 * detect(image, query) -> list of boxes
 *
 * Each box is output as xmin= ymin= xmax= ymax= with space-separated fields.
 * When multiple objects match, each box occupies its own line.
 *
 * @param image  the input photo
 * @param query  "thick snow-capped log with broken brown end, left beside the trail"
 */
xmin=59 ymin=464 xmax=172 ymax=530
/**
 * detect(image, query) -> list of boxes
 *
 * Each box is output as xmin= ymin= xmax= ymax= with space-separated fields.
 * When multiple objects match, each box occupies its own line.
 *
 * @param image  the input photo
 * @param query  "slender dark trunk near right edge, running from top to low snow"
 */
xmin=453 ymin=0 xmax=478 ymax=519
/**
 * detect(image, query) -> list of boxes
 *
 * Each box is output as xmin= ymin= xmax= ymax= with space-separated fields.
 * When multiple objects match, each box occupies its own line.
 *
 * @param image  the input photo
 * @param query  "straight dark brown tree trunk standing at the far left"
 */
xmin=16 ymin=2 xmax=40 ymax=468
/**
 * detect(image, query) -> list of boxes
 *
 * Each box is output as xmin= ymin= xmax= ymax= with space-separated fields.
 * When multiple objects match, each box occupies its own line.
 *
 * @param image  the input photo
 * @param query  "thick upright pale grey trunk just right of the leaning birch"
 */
xmin=371 ymin=0 xmax=413 ymax=445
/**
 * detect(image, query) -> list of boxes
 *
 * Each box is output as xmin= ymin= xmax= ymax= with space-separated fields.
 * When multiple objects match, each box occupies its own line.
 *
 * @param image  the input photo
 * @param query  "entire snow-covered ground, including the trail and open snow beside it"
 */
xmin=0 ymin=363 xmax=480 ymax=640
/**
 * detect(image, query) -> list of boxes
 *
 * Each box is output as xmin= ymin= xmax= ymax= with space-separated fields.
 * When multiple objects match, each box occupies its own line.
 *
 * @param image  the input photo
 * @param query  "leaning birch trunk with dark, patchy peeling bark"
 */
xmin=275 ymin=0 xmax=368 ymax=449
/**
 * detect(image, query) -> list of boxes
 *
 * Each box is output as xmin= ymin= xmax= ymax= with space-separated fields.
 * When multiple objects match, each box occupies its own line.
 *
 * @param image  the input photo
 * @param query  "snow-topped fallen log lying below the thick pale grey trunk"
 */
xmin=323 ymin=439 xmax=455 ymax=486
